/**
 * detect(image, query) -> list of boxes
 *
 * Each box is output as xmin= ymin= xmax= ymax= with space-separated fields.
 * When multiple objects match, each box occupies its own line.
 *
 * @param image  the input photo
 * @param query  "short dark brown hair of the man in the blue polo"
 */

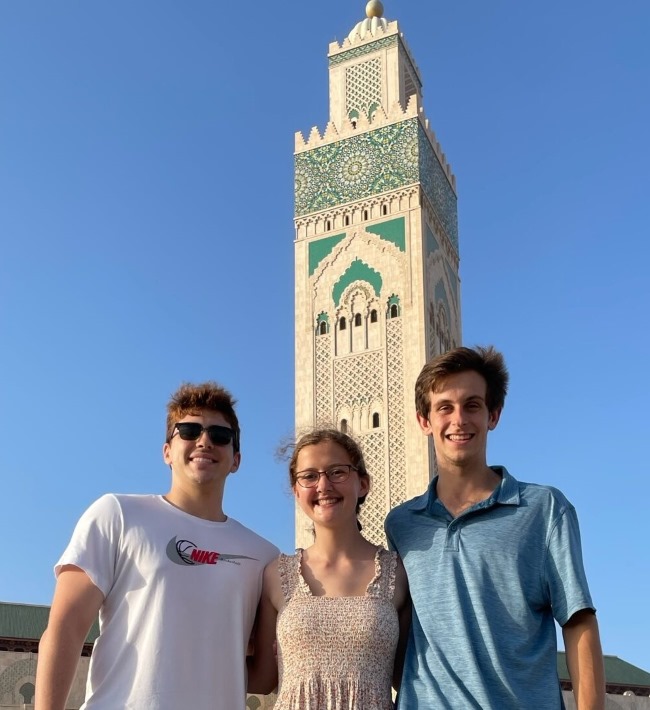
xmin=415 ymin=345 xmax=509 ymax=418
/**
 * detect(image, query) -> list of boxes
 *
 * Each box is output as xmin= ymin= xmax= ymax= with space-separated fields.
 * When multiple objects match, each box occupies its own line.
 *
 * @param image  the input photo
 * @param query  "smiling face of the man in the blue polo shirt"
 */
xmin=417 ymin=370 xmax=501 ymax=470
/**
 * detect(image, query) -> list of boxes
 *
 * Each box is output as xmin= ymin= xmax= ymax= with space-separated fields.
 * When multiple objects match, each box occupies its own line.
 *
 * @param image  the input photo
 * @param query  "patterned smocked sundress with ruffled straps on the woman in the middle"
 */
xmin=275 ymin=549 xmax=399 ymax=710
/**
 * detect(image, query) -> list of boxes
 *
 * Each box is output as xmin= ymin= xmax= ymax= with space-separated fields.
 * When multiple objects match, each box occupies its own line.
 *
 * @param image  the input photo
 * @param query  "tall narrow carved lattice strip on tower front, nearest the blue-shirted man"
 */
xmin=386 ymin=318 xmax=406 ymax=508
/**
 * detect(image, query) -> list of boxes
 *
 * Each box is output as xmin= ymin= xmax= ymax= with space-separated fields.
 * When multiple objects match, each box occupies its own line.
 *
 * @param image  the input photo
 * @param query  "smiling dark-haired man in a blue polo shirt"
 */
xmin=386 ymin=347 xmax=605 ymax=710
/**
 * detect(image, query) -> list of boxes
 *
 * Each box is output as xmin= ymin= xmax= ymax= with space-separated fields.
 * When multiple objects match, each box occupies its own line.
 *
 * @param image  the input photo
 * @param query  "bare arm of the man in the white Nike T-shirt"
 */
xmin=35 ymin=565 xmax=104 ymax=710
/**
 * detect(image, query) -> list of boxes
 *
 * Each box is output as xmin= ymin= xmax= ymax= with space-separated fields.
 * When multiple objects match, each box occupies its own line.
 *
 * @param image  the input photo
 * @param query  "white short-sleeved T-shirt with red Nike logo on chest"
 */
xmin=55 ymin=494 xmax=278 ymax=710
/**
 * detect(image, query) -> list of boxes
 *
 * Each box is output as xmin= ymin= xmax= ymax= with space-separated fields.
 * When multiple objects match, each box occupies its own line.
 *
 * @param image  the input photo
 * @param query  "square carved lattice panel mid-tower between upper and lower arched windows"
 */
xmin=334 ymin=351 xmax=383 ymax=409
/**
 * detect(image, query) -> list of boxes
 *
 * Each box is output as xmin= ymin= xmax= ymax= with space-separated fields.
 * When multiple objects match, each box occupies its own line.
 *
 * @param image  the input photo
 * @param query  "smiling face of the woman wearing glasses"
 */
xmin=293 ymin=441 xmax=370 ymax=527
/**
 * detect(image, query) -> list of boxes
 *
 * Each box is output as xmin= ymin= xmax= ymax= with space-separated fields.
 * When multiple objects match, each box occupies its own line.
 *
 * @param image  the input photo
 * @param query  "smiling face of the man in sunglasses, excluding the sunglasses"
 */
xmin=163 ymin=410 xmax=240 ymax=491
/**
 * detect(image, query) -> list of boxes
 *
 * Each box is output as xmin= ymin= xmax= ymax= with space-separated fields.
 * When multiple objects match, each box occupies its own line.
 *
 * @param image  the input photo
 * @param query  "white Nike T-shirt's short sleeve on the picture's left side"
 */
xmin=54 ymin=494 xmax=124 ymax=597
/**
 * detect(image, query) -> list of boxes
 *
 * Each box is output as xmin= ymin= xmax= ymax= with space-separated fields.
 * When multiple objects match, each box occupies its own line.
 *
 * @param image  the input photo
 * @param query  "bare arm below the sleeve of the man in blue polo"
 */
xmin=562 ymin=609 xmax=605 ymax=710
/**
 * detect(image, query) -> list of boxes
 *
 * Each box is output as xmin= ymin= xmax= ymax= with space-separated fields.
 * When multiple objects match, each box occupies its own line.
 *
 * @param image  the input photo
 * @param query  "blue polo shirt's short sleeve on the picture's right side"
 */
xmin=545 ymin=504 xmax=595 ymax=626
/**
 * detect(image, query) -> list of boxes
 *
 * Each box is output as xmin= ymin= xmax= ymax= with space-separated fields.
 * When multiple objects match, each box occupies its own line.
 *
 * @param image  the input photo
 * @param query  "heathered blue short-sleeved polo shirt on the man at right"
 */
xmin=386 ymin=466 xmax=594 ymax=710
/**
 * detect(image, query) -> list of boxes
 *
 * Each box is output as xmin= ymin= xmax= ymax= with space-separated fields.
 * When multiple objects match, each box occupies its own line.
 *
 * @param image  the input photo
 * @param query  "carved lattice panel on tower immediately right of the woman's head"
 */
xmin=359 ymin=430 xmax=388 ymax=546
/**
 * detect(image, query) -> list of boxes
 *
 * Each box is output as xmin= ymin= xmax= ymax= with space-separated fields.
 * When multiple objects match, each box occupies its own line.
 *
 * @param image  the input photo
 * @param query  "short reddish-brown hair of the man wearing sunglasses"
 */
xmin=165 ymin=381 xmax=240 ymax=453
